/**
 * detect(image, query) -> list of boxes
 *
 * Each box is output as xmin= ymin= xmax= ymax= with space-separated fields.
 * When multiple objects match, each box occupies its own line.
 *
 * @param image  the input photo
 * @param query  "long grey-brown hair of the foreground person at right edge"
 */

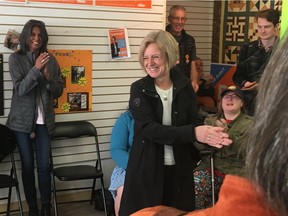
xmin=247 ymin=31 xmax=288 ymax=215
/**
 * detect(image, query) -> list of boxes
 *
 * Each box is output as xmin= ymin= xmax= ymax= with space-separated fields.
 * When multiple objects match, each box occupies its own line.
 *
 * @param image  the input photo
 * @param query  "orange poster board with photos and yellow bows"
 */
xmin=49 ymin=50 xmax=92 ymax=113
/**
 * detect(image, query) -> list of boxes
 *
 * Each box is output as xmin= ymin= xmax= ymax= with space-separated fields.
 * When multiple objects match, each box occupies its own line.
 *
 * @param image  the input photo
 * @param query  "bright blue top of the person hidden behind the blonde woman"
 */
xmin=110 ymin=111 xmax=134 ymax=169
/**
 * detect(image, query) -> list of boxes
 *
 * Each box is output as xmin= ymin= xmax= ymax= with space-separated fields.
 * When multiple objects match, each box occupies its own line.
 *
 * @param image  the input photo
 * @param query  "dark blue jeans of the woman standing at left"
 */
xmin=14 ymin=125 xmax=51 ymax=208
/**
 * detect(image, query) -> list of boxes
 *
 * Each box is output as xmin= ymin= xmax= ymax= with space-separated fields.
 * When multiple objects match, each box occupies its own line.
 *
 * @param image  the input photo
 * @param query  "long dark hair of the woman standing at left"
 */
xmin=19 ymin=19 xmax=48 ymax=54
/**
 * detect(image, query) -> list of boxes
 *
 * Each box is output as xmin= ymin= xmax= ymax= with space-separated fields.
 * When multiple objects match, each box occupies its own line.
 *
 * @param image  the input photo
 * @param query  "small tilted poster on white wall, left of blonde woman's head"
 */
xmin=108 ymin=28 xmax=131 ymax=59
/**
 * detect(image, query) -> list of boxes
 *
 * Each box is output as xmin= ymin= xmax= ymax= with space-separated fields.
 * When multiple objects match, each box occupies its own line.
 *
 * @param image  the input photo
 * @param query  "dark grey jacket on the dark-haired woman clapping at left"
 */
xmin=7 ymin=52 xmax=63 ymax=134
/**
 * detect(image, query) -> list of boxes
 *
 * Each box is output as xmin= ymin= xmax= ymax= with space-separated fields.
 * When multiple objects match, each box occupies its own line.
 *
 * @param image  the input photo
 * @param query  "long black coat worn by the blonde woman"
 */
xmin=120 ymin=66 xmax=199 ymax=216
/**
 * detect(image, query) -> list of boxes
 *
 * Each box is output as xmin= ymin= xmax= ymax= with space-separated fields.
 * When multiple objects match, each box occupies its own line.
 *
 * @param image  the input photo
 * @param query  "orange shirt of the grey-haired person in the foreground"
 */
xmin=132 ymin=175 xmax=277 ymax=216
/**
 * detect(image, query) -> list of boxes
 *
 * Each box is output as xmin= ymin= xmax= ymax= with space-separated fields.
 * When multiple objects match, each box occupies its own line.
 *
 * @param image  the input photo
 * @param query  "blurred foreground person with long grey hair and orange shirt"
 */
xmin=133 ymin=31 xmax=288 ymax=216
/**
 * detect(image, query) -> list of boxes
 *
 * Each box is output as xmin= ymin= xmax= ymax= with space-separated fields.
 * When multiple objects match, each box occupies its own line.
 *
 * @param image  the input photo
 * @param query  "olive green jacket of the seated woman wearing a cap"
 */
xmin=195 ymin=113 xmax=253 ymax=176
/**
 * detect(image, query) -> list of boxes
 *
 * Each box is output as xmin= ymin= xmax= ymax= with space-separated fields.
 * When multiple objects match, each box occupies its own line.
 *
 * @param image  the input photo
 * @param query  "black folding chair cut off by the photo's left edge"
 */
xmin=0 ymin=124 xmax=23 ymax=216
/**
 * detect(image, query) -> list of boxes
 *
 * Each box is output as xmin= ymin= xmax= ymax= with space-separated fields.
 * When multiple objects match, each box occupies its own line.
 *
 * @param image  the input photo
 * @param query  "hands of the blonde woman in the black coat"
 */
xmin=195 ymin=125 xmax=232 ymax=148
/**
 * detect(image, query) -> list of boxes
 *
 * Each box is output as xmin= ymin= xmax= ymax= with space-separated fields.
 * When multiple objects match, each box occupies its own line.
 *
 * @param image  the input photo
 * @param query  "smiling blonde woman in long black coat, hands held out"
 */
xmin=119 ymin=30 xmax=231 ymax=216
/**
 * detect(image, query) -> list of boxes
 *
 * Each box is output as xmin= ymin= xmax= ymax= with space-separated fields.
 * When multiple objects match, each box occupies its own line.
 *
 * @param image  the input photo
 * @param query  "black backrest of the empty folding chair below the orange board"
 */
xmin=51 ymin=121 xmax=102 ymax=170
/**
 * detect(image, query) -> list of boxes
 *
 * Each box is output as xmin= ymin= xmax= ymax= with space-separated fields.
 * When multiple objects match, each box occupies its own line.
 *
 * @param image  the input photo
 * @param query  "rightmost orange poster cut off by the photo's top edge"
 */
xmin=96 ymin=0 xmax=152 ymax=8
